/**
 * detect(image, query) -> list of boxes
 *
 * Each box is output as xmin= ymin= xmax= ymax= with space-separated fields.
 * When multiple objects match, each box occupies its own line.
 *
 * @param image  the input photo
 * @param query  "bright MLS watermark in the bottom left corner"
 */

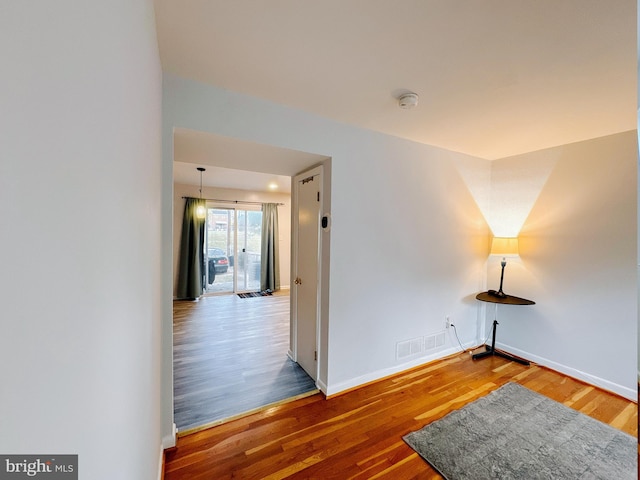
xmin=0 ymin=455 xmax=78 ymax=480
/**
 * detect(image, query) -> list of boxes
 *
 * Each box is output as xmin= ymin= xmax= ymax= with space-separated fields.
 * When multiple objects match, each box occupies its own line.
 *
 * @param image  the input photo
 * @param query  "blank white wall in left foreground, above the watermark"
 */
xmin=0 ymin=0 xmax=162 ymax=480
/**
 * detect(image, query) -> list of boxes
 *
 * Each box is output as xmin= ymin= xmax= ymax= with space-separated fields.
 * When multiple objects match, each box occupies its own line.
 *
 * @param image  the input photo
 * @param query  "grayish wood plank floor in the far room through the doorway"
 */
xmin=173 ymin=291 xmax=316 ymax=432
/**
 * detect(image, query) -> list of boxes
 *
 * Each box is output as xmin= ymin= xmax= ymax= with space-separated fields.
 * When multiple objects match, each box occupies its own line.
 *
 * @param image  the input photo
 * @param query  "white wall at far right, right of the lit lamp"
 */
xmin=487 ymin=131 xmax=638 ymax=399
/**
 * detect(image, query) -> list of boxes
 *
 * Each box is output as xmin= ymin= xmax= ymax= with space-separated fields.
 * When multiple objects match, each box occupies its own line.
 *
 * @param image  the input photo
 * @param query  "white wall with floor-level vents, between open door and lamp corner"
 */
xmin=328 ymin=139 xmax=488 ymax=393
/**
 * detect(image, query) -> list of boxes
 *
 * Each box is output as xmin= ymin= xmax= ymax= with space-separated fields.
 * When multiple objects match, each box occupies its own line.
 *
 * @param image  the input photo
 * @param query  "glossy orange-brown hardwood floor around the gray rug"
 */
xmin=165 ymin=353 xmax=638 ymax=480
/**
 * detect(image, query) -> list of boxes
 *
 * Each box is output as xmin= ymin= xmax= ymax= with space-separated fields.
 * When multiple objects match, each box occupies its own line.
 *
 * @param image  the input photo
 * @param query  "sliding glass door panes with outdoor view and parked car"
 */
xmin=206 ymin=208 xmax=262 ymax=293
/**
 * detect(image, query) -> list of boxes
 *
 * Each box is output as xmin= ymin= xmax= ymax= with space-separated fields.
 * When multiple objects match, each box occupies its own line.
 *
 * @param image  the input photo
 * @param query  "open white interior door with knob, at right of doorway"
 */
xmin=292 ymin=168 xmax=322 ymax=380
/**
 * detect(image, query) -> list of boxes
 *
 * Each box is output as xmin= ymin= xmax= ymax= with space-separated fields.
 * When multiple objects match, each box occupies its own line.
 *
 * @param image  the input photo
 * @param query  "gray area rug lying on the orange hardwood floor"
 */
xmin=404 ymin=383 xmax=638 ymax=480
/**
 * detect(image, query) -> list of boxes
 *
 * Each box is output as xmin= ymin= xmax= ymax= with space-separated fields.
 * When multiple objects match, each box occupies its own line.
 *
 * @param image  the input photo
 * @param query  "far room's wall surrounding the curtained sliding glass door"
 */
xmin=173 ymin=183 xmax=291 ymax=298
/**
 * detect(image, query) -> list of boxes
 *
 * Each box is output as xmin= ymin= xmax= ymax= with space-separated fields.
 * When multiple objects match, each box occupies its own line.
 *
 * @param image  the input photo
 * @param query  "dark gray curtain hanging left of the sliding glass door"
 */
xmin=176 ymin=198 xmax=206 ymax=298
